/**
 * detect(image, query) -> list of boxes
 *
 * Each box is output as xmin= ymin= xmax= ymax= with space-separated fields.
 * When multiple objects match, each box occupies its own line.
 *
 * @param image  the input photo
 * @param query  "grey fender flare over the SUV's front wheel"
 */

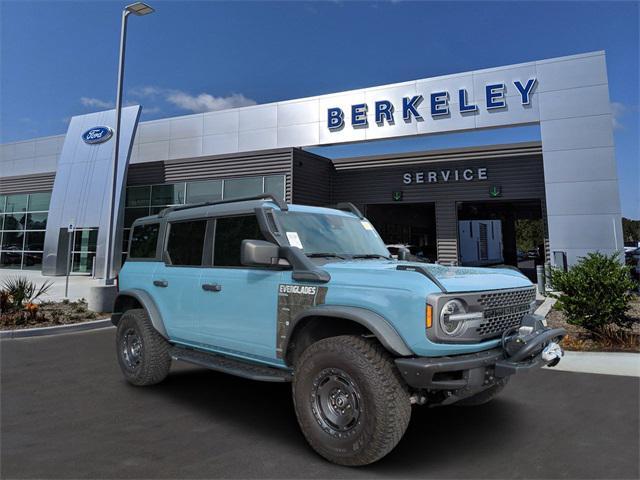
xmin=282 ymin=305 xmax=415 ymax=357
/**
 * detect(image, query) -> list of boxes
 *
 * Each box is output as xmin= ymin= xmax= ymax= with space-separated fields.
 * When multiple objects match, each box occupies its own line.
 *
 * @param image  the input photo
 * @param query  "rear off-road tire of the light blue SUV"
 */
xmin=116 ymin=308 xmax=171 ymax=386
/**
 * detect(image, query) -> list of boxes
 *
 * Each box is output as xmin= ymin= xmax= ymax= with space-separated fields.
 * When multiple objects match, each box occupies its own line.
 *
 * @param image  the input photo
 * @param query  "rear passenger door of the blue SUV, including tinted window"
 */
xmin=150 ymin=219 xmax=209 ymax=345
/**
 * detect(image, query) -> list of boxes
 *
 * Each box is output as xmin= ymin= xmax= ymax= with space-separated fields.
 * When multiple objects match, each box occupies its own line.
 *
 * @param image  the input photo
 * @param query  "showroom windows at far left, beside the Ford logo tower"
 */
xmin=0 ymin=192 xmax=51 ymax=270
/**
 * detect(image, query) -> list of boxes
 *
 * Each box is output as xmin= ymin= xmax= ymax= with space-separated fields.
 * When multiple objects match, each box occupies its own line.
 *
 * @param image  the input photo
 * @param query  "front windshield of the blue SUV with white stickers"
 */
xmin=278 ymin=211 xmax=389 ymax=258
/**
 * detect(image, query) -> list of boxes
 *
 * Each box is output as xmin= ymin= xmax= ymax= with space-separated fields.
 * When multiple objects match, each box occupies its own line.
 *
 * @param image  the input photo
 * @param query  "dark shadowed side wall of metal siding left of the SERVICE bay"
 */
xmin=293 ymin=148 xmax=335 ymax=206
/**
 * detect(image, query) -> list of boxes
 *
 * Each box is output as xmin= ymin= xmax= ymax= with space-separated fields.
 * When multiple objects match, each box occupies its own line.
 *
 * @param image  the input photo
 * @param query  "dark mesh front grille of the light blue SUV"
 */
xmin=476 ymin=287 xmax=536 ymax=339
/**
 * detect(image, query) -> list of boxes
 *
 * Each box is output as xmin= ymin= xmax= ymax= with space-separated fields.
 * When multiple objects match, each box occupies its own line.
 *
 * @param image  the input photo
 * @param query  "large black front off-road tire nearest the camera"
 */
xmin=293 ymin=335 xmax=411 ymax=466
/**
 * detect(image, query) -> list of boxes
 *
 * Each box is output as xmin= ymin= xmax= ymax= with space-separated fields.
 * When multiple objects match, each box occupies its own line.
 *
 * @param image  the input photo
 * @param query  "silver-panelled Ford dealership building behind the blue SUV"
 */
xmin=0 ymin=52 xmax=622 ymax=277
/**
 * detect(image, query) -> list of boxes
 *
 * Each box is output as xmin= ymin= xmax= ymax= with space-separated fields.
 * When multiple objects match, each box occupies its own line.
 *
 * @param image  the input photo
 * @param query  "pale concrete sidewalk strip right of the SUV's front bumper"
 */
xmin=548 ymin=352 xmax=640 ymax=377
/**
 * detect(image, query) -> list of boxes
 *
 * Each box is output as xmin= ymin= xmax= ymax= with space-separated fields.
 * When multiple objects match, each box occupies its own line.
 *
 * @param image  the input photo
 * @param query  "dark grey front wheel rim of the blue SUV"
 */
xmin=311 ymin=368 xmax=363 ymax=437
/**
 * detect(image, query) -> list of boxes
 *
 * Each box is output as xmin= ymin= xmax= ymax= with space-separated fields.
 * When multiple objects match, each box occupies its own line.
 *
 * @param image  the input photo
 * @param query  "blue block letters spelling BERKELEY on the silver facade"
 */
xmin=327 ymin=78 xmax=537 ymax=130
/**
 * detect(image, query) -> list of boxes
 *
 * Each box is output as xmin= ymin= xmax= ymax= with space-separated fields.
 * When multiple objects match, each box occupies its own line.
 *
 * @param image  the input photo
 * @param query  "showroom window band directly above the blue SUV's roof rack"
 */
xmin=122 ymin=175 xmax=285 ymax=262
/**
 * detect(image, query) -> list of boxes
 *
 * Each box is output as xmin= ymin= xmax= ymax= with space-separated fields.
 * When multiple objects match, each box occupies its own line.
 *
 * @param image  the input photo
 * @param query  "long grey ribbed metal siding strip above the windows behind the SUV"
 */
xmin=127 ymin=148 xmax=293 ymax=201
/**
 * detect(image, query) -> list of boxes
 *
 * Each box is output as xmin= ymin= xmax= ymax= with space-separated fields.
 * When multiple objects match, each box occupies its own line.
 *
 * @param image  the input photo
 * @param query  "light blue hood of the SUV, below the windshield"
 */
xmin=321 ymin=260 xmax=531 ymax=293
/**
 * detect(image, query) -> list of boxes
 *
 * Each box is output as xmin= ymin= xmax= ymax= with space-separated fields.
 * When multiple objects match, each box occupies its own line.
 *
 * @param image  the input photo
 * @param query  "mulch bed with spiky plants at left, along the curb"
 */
xmin=0 ymin=299 xmax=108 ymax=330
